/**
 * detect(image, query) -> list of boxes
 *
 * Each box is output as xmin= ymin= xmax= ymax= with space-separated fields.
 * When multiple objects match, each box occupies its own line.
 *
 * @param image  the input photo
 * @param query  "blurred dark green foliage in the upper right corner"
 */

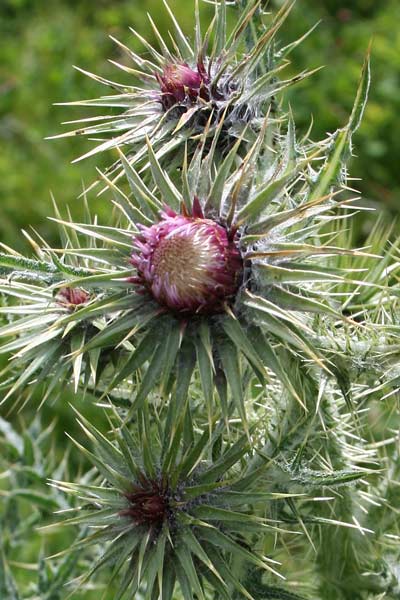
xmin=276 ymin=0 xmax=400 ymax=220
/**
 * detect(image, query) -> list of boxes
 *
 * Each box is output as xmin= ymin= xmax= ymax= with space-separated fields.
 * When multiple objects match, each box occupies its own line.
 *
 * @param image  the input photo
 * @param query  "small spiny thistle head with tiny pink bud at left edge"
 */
xmin=0 ymin=237 xmax=114 ymax=402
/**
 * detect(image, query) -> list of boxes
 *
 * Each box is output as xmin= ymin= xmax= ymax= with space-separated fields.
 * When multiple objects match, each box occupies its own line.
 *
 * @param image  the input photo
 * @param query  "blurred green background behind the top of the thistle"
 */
xmin=0 ymin=0 xmax=400 ymax=248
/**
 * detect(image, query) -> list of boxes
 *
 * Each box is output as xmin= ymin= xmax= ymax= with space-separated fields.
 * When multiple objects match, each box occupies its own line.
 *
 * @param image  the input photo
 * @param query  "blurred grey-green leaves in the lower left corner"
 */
xmin=0 ymin=406 xmax=119 ymax=600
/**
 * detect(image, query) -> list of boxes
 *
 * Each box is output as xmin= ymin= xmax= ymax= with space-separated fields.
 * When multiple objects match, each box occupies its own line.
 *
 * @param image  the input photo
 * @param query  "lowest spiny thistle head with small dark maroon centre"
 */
xmin=54 ymin=414 xmax=295 ymax=600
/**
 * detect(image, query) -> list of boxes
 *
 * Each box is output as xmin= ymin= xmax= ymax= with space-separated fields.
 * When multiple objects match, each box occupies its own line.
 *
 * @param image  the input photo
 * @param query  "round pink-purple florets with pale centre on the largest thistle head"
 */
xmin=131 ymin=201 xmax=242 ymax=313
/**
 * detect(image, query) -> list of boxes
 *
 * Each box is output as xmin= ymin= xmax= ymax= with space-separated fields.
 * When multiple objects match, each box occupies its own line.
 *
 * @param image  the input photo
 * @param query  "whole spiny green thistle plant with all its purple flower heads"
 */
xmin=0 ymin=0 xmax=400 ymax=600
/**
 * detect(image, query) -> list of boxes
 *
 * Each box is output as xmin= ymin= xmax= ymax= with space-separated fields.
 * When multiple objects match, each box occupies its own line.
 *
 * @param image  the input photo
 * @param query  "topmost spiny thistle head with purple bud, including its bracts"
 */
xmin=50 ymin=2 xmax=309 ymax=174
